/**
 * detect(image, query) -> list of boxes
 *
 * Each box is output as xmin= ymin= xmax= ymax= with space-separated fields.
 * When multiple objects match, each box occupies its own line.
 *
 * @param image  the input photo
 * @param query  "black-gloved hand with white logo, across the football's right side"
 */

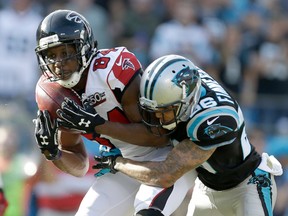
xmin=57 ymin=98 xmax=105 ymax=133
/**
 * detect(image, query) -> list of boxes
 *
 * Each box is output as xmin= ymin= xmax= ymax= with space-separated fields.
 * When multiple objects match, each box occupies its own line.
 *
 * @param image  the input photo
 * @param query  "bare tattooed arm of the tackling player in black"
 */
xmin=114 ymin=139 xmax=215 ymax=188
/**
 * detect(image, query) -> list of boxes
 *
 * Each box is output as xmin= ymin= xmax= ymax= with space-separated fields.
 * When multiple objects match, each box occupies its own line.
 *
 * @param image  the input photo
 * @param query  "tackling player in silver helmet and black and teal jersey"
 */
xmin=95 ymin=55 xmax=283 ymax=216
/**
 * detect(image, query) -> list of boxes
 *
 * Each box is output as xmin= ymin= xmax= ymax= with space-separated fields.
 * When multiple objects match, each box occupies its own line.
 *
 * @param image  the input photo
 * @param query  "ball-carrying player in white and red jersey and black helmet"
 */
xmin=34 ymin=10 xmax=195 ymax=216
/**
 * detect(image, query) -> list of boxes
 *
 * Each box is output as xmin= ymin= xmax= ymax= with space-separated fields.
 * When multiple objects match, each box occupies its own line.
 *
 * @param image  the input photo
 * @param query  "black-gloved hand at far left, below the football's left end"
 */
xmin=33 ymin=110 xmax=61 ymax=160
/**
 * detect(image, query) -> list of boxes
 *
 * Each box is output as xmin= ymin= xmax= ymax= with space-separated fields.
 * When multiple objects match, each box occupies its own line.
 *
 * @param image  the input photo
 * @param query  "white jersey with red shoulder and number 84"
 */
xmin=82 ymin=47 xmax=170 ymax=160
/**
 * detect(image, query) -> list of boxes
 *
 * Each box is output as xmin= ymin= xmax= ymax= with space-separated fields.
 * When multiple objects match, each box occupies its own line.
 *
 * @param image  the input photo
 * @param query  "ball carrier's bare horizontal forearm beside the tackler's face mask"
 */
xmin=96 ymin=121 xmax=169 ymax=147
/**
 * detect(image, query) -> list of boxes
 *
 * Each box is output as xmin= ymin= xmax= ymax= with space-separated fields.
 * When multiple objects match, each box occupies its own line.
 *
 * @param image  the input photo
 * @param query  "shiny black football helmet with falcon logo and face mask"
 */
xmin=35 ymin=10 xmax=97 ymax=88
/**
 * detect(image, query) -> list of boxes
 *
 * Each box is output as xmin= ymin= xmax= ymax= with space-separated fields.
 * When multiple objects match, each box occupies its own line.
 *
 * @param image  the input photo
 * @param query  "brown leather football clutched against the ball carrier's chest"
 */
xmin=35 ymin=75 xmax=82 ymax=119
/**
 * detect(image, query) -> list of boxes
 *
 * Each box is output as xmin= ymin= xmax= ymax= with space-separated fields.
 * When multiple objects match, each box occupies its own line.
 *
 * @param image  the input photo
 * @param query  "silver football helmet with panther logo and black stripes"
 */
xmin=139 ymin=55 xmax=201 ymax=134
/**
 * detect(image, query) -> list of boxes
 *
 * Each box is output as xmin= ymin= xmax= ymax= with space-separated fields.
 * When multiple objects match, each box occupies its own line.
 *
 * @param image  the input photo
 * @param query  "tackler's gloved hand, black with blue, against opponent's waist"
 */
xmin=92 ymin=146 xmax=121 ymax=177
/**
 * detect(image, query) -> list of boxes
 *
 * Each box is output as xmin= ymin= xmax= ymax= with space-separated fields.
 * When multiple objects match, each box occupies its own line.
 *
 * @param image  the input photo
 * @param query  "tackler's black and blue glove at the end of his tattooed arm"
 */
xmin=92 ymin=150 xmax=121 ymax=176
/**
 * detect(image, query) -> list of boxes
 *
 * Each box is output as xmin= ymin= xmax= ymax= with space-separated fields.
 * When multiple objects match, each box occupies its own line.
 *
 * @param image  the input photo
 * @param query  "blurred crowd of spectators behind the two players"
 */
xmin=0 ymin=0 xmax=288 ymax=216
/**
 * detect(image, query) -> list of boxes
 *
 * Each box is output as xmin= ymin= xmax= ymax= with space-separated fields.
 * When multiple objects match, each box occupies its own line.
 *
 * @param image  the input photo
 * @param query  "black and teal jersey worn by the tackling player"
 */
xmin=172 ymin=70 xmax=261 ymax=190
